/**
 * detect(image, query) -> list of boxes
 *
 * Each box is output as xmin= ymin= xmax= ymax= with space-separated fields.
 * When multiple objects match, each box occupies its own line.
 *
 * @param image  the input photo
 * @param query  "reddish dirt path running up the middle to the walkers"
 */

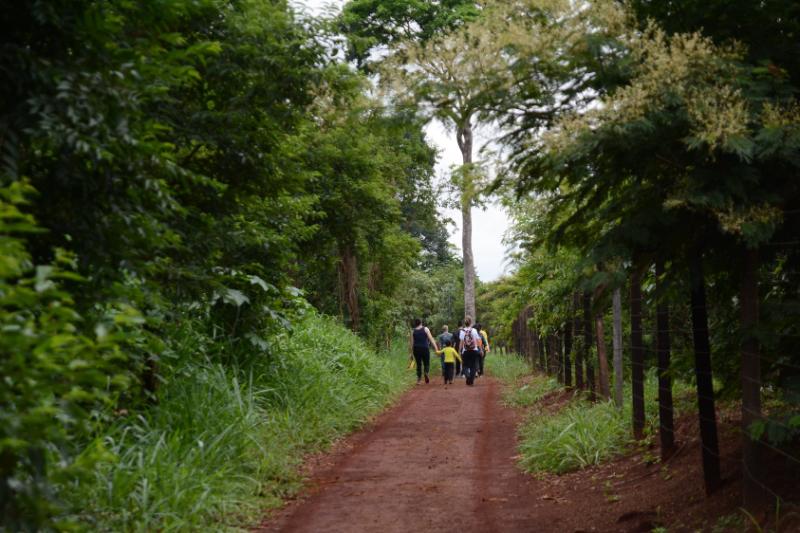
xmin=261 ymin=378 xmax=573 ymax=533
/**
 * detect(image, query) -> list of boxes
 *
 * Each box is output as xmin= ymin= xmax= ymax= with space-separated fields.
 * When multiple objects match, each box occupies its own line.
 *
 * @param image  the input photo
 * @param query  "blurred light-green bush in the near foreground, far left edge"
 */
xmin=0 ymin=182 xmax=142 ymax=530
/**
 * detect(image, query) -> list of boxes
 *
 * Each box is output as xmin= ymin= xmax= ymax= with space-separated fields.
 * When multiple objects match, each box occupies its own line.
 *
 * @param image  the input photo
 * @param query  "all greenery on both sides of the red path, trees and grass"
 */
xmin=0 ymin=0 xmax=800 ymax=530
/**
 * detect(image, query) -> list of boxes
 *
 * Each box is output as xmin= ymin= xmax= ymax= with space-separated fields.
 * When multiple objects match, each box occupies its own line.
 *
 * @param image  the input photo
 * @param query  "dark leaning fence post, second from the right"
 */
xmin=689 ymin=250 xmax=721 ymax=494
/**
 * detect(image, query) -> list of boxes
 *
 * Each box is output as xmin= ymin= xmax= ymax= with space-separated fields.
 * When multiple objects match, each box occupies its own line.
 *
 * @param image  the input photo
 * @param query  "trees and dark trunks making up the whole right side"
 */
xmin=468 ymin=0 xmax=800 ymax=507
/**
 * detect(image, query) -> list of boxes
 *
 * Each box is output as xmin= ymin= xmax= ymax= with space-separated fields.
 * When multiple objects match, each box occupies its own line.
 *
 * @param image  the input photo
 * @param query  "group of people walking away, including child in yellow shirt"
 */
xmin=409 ymin=316 xmax=489 ymax=386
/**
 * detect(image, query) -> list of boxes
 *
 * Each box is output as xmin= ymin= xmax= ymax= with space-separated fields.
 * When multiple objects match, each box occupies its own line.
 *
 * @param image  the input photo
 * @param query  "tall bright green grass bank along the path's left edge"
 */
xmin=73 ymin=314 xmax=410 ymax=531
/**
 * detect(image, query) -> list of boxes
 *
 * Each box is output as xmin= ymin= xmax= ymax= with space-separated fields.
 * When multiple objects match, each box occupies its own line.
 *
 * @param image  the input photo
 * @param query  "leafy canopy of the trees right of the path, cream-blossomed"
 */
xmin=490 ymin=0 xmax=800 ymax=442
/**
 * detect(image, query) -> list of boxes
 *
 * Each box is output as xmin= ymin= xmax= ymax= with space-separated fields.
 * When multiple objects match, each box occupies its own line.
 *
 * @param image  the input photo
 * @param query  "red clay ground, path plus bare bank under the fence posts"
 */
xmin=258 ymin=378 xmax=795 ymax=533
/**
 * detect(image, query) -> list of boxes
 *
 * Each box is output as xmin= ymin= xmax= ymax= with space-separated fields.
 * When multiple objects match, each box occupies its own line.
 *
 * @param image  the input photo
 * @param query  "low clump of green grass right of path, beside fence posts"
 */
xmin=519 ymin=372 xmax=694 ymax=474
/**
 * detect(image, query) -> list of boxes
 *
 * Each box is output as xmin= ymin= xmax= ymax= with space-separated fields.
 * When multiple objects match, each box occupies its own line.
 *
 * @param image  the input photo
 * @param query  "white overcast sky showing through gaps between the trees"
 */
xmin=291 ymin=0 xmax=509 ymax=281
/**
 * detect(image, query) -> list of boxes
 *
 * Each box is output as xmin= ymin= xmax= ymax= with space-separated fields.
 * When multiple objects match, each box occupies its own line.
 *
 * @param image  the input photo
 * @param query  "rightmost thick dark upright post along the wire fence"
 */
xmin=741 ymin=249 xmax=768 ymax=511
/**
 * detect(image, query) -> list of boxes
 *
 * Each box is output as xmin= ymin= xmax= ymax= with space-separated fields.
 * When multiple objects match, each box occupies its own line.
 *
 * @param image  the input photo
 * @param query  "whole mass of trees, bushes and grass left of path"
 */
xmin=0 ymin=0 xmax=457 ymax=530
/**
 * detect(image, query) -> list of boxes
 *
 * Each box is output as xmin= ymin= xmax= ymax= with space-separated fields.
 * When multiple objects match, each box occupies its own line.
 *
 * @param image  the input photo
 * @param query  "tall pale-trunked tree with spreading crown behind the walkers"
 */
xmin=380 ymin=0 xmax=622 ymax=317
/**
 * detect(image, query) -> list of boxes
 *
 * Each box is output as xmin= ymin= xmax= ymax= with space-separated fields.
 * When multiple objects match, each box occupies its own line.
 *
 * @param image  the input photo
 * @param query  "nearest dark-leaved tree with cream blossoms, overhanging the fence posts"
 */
xmin=517 ymin=17 xmax=800 ymax=493
